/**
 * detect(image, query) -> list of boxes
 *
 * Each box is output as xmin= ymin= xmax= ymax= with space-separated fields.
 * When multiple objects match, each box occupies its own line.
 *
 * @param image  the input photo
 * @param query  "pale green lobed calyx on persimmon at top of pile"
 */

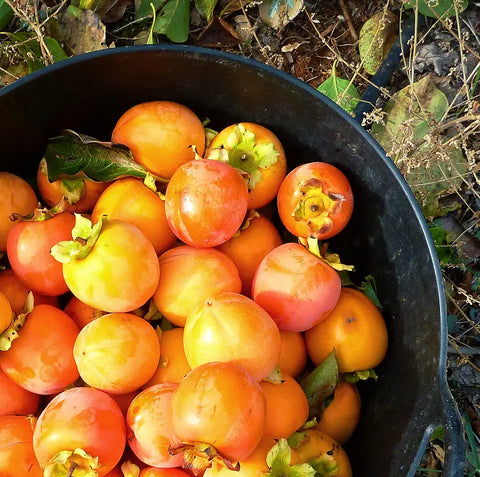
xmin=226 ymin=123 xmax=280 ymax=190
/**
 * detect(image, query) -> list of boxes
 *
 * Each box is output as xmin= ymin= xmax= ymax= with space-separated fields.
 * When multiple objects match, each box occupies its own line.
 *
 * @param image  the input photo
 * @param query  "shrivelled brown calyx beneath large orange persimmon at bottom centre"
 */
xmin=168 ymin=442 xmax=240 ymax=475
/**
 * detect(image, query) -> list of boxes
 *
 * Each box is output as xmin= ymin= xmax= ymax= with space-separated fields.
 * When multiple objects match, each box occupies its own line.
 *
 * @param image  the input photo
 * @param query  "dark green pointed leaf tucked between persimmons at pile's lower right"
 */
xmin=300 ymin=350 xmax=338 ymax=419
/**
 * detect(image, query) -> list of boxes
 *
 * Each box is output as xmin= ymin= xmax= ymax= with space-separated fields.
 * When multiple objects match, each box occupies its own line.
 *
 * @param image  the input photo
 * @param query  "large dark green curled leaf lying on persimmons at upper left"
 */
xmin=45 ymin=130 xmax=152 ymax=182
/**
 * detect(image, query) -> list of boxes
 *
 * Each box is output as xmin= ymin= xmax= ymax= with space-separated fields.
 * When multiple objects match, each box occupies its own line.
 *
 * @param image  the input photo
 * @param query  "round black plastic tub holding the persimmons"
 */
xmin=0 ymin=46 xmax=464 ymax=477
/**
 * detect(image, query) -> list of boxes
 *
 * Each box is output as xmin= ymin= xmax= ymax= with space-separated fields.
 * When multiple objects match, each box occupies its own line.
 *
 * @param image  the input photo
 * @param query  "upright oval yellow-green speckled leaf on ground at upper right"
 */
xmin=358 ymin=10 xmax=397 ymax=75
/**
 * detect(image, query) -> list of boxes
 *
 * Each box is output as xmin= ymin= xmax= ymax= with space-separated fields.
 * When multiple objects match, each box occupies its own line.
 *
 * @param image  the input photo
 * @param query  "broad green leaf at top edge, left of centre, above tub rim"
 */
xmin=153 ymin=0 xmax=190 ymax=43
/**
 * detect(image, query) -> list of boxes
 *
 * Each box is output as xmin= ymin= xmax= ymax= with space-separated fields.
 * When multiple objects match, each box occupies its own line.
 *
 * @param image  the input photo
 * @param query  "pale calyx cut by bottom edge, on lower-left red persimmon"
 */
xmin=43 ymin=449 xmax=100 ymax=477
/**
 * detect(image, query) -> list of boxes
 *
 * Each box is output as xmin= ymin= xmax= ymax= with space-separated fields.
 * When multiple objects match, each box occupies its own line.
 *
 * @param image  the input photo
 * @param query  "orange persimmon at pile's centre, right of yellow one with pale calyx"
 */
xmin=153 ymin=245 xmax=242 ymax=326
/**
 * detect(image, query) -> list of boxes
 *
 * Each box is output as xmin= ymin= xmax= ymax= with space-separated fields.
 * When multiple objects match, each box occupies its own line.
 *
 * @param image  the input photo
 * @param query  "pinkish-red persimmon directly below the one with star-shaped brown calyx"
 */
xmin=252 ymin=243 xmax=341 ymax=331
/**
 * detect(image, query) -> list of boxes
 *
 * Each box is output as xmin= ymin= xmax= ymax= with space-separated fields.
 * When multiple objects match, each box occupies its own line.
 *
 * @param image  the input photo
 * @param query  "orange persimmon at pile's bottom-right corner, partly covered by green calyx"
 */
xmin=291 ymin=429 xmax=352 ymax=477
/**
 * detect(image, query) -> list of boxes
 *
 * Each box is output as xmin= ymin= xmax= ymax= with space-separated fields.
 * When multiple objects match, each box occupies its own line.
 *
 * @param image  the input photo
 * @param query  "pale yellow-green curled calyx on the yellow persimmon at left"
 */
xmin=50 ymin=213 xmax=105 ymax=263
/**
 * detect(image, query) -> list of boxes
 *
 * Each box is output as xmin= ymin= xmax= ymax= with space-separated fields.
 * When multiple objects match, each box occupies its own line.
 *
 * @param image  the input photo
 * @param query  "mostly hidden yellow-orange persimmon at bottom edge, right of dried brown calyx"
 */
xmin=203 ymin=436 xmax=276 ymax=477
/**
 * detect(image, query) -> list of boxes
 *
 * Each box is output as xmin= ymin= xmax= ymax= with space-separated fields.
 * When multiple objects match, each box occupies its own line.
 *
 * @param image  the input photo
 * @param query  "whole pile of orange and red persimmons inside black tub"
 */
xmin=0 ymin=101 xmax=387 ymax=477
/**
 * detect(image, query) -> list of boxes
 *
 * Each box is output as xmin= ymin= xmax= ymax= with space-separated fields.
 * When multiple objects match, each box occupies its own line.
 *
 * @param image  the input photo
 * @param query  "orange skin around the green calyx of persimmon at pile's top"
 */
xmin=209 ymin=122 xmax=287 ymax=209
